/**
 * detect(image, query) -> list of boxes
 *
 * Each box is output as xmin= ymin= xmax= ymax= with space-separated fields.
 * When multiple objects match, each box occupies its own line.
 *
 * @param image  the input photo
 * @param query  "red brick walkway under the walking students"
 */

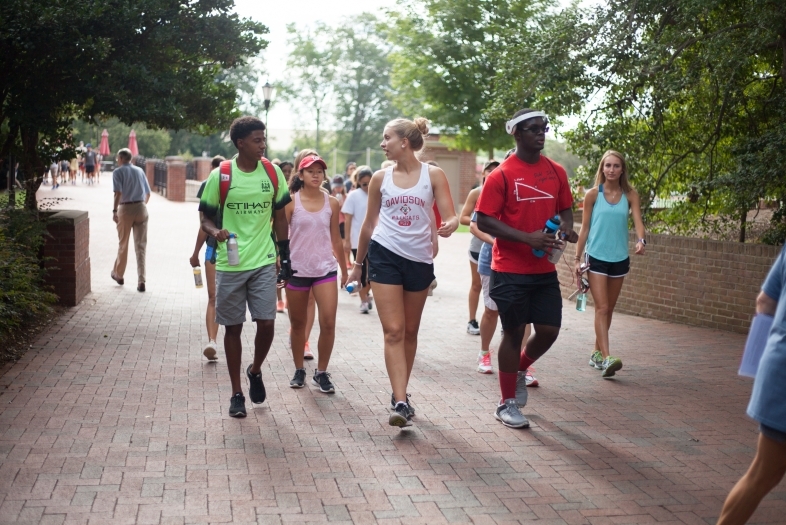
xmin=0 ymin=181 xmax=786 ymax=525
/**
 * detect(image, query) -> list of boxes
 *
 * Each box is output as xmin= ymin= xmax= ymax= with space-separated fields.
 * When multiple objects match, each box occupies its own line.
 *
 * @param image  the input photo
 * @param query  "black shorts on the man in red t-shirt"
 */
xmin=489 ymin=270 xmax=562 ymax=331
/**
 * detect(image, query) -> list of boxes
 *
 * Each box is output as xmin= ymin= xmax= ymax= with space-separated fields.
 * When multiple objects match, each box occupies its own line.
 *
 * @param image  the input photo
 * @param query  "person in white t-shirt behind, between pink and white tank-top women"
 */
xmin=341 ymin=166 xmax=374 ymax=314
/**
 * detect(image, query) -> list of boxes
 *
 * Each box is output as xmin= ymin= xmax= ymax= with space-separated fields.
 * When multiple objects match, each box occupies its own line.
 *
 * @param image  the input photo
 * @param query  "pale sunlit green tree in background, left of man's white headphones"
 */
xmin=390 ymin=0 xmax=552 ymax=157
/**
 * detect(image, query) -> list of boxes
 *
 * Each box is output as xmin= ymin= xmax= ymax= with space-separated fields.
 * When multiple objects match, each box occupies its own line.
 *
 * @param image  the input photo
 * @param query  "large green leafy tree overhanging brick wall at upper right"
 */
xmin=495 ymin=0 xmax=786 ymax=241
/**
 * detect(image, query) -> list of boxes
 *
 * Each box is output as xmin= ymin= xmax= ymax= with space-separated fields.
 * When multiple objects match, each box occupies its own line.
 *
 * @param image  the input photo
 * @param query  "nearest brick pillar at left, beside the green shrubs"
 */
xmin=44 ymin=210 xmax=90 ymax=306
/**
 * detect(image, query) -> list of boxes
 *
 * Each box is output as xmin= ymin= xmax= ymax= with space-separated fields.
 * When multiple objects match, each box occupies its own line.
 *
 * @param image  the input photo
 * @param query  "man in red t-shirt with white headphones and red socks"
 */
xmin=476 ymin=109 xmax=578 ymax=428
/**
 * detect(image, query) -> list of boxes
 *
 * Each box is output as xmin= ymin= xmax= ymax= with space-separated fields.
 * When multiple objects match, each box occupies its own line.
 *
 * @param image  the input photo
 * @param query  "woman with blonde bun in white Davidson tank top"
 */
xmin=349 ymin=118 xmax=458 ymax=427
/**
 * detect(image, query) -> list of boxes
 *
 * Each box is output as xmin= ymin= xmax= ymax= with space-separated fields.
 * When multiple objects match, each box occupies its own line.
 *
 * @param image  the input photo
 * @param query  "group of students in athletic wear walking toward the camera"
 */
xmin=191 ymin=110 xmax=645 ymax=428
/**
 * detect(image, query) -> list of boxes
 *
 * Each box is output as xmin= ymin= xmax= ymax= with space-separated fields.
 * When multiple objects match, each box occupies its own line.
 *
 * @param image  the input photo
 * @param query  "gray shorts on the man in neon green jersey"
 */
xmin=216 ymin=264 xmax=277 ymax=326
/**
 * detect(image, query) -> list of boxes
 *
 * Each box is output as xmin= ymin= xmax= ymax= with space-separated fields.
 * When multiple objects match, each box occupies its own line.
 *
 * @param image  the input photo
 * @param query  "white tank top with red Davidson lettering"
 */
xmin=371 ymin=162 xmax=434 ymax=264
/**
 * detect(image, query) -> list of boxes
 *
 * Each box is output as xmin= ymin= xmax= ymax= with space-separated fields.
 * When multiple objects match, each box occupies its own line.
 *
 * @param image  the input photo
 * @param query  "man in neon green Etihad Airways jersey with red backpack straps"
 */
xmin=199 ymin=117 xmax=292 ymax=417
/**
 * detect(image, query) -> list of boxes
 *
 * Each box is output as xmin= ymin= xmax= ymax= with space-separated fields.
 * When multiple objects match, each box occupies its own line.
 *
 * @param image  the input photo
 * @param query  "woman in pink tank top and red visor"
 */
xmin=286 ymin=155 xmax=347 ymax=394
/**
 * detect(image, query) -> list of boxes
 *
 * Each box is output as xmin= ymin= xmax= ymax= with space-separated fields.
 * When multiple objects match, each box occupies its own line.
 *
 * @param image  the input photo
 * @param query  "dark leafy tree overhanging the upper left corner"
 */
xmin=0 ymin=0 xmax=267 ymax=208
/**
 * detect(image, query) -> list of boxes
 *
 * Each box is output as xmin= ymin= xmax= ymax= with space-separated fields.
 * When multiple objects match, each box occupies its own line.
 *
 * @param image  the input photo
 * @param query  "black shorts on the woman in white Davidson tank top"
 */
xmin=368 ymin=241 xmax=434 ymax=292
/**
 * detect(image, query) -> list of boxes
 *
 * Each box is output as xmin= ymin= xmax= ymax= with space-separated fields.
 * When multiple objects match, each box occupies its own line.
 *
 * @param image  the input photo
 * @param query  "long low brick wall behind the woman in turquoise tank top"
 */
xmin=557 ymin=214 xmax=781 ymax=333
